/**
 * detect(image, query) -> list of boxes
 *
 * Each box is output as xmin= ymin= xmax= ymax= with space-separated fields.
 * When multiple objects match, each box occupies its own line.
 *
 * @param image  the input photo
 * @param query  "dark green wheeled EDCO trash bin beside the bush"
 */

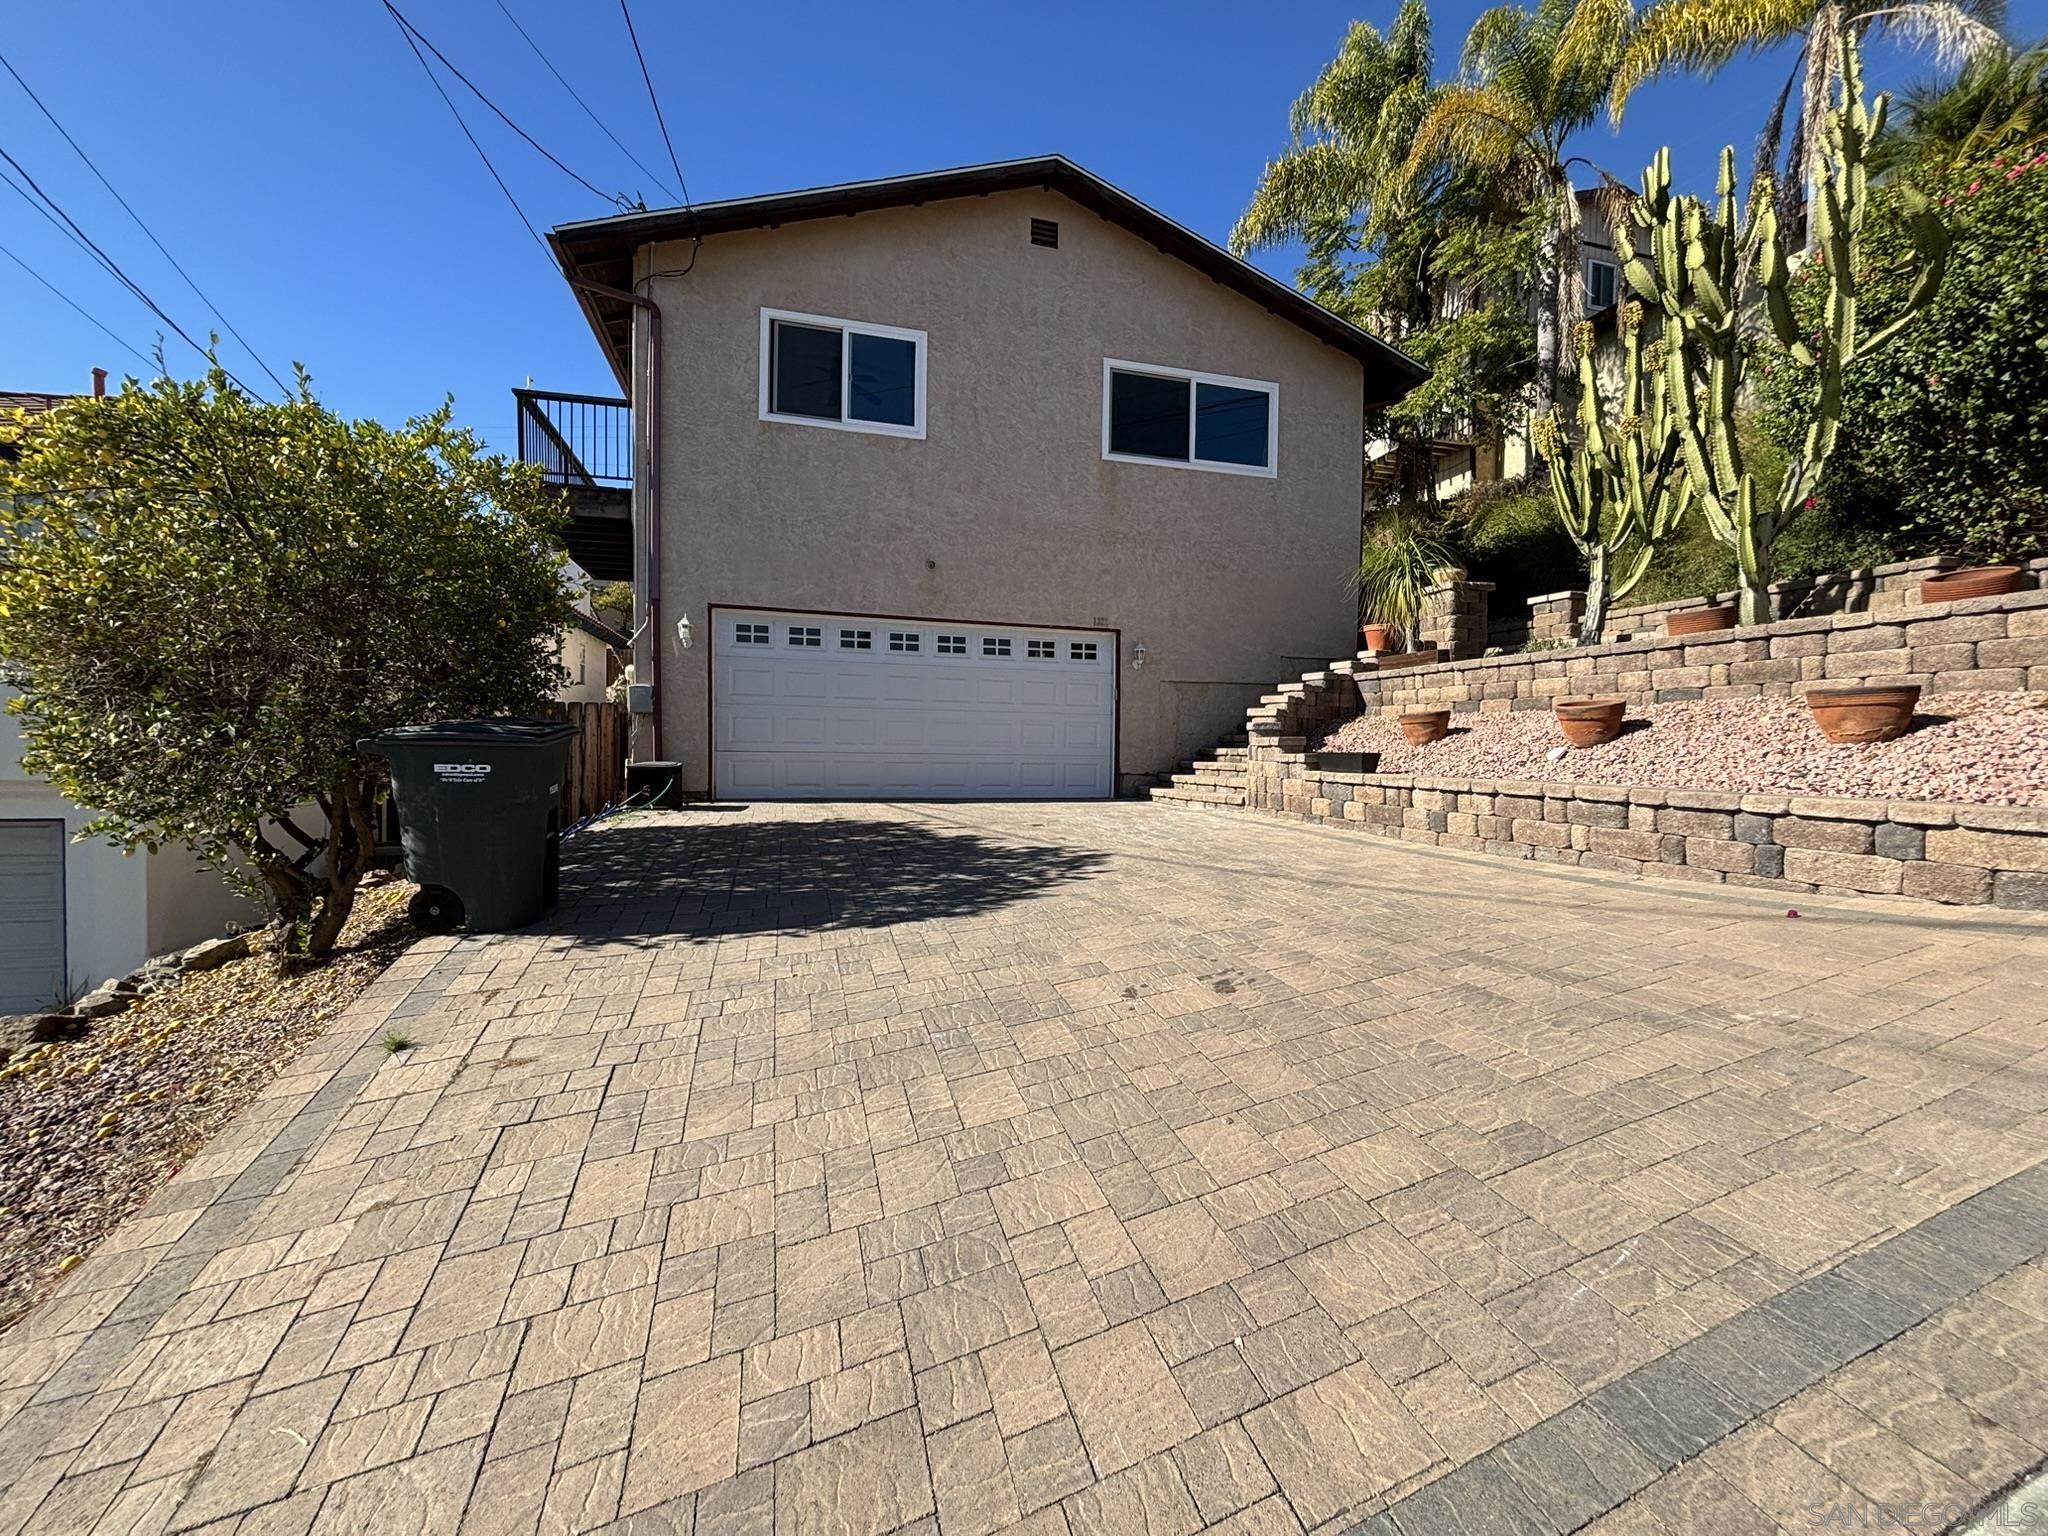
xmin=356 ymin=719 xmax=575 ymax=934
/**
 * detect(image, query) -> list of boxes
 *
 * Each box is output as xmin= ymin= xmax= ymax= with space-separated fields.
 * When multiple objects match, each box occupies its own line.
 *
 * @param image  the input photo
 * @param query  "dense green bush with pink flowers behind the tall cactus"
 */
xmin=1757 ymin=143 xmax=2048 ymax=559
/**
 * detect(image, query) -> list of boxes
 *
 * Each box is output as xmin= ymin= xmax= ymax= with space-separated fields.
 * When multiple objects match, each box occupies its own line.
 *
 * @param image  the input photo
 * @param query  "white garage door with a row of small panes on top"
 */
xmin=711 ymin=610 xmax=1116 ymax=801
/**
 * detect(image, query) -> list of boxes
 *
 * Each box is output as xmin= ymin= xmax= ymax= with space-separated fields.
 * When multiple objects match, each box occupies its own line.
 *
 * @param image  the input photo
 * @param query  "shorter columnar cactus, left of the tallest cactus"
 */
xmin=1536 ymin=301 xmax=1694 ymax=645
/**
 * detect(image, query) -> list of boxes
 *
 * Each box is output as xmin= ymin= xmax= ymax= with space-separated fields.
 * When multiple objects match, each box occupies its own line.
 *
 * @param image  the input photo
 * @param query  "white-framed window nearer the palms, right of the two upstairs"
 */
xmin=1102 ymin=358 xmax=1280 ymax=479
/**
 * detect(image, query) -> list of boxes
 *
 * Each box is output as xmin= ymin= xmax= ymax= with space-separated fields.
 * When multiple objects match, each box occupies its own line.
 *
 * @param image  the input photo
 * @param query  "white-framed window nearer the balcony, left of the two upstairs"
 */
xmin=760 ymin=309 xmax=926 ymax=438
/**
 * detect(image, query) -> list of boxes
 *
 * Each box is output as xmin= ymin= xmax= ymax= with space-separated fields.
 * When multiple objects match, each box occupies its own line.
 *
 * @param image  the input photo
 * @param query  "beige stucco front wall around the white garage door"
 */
xmin=639 ymin=193 xmax=1364 ymax=791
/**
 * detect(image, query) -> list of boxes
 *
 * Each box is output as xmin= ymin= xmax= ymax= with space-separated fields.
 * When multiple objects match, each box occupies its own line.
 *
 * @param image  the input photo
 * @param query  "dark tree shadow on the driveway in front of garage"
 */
xmin=549 ymin=815 xmax=1108 ymax=942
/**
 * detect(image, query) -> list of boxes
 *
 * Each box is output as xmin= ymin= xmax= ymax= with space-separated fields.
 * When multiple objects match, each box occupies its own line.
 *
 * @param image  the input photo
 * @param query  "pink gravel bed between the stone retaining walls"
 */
xmin=1315 ymin=692 xmax=2048 ymax=805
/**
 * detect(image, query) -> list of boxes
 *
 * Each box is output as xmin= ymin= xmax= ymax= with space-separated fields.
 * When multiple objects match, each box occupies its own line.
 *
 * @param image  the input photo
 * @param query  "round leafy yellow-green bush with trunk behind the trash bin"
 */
xmin=0 ymin=369 xmax=569 ymax=954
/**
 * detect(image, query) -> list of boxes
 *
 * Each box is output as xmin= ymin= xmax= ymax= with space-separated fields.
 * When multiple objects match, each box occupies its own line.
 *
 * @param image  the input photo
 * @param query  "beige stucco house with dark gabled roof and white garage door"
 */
xmin=522 ymin=156 xmax=1423 ymax=799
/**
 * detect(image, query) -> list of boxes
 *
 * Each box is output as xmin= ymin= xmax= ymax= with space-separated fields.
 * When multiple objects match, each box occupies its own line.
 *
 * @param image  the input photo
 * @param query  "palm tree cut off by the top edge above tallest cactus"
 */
xmin=1608 ymin=0 xmax=2005 ymax=238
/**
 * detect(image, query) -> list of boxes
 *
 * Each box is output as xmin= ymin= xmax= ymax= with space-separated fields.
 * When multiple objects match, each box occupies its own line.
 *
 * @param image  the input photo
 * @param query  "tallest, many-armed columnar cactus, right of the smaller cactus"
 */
xmin=1626 ymin=33 xmax=1948 ymax=625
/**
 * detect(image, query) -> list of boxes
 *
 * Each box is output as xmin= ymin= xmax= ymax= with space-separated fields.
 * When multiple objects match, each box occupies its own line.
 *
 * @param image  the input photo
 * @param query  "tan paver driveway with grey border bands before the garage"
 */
xmin=0 ymin=805 xmax=2048 ymax=1536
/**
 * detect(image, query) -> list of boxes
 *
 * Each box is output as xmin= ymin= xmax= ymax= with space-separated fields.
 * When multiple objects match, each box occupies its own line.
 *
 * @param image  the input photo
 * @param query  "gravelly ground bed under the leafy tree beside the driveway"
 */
xmin=0 ymin=883 xmax=418 ymax=1329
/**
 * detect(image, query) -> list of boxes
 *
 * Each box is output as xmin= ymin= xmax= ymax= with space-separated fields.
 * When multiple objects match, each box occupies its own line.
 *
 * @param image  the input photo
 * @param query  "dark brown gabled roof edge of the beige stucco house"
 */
xmin=549 ymin=156 xmax=1430 ymax=406
